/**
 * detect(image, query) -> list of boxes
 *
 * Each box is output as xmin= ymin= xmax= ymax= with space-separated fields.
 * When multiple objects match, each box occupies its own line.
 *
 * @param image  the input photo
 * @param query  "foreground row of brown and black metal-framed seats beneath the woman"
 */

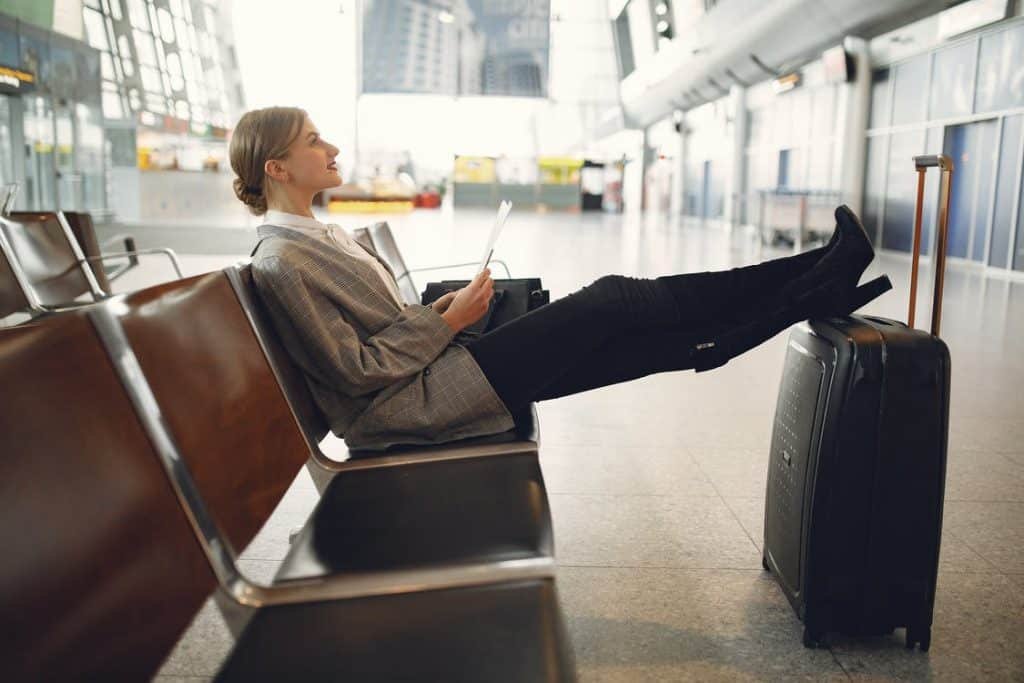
xmin=0 ymin=265 xmax=574 ymax=681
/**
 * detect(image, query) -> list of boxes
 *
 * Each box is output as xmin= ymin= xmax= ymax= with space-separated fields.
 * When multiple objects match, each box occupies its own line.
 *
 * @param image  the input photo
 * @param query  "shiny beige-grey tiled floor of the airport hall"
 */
xmin=136 ymin=212 xmax=1024 ymax=682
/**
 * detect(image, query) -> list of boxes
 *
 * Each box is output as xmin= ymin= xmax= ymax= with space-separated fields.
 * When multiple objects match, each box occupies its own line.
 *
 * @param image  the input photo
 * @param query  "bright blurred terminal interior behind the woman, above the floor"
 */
xmin=0 ymin=0 xmax=1024 ymax=272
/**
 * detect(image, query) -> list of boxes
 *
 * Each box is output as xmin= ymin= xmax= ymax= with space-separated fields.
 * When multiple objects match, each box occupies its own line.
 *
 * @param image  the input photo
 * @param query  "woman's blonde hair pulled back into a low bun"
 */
xmin=228 ymin=106 xmax=306 ymax=216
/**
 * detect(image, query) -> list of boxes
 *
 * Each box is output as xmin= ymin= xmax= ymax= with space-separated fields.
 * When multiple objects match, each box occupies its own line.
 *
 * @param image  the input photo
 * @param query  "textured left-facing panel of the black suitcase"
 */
xmin=765 ymin=342 xmax=825 ymax=595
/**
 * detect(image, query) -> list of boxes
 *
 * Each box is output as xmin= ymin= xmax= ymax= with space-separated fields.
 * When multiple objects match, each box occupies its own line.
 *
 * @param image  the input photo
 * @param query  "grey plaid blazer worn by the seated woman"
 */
xmin=252 ymin=225 xmax=514 ymax=449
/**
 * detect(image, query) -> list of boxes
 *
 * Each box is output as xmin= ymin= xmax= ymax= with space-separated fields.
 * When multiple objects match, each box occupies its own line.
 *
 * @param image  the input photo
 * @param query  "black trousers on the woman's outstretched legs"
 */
xmin=465 ymin=248 xmax=824 ymax=414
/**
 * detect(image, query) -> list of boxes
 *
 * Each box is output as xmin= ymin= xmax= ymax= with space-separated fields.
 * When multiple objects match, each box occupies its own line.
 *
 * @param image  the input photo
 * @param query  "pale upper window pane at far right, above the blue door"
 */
xmin=975 ymin=26 xmax=1024 ymax=112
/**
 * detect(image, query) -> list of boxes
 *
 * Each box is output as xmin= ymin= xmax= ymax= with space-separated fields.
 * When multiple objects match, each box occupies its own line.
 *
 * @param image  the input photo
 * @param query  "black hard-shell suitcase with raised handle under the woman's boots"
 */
xmin=763 ymin=157 xmax=952 ymax=650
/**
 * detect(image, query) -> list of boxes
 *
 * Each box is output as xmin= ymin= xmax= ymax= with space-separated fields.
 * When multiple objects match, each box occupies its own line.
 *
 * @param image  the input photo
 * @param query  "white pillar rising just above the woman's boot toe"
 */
xmin=837 ymin=36 xmax=871 ymax=214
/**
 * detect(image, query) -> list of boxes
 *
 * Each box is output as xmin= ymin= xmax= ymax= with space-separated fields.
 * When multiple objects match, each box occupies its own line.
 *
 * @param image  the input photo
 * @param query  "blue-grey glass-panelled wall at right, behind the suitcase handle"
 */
xmin=864 ymin=20 xmax=1024 ymax=270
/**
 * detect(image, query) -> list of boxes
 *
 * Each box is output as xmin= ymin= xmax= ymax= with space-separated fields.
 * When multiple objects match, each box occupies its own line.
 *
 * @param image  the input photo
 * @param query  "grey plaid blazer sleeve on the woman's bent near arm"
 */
xmin=253 ymin=256 xmax=455 ymax=396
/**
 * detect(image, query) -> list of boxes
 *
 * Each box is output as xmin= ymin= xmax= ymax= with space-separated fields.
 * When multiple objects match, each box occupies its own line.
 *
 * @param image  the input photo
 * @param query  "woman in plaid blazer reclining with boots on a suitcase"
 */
xmin=230 ymin=108 xmax=888 ymax=449
